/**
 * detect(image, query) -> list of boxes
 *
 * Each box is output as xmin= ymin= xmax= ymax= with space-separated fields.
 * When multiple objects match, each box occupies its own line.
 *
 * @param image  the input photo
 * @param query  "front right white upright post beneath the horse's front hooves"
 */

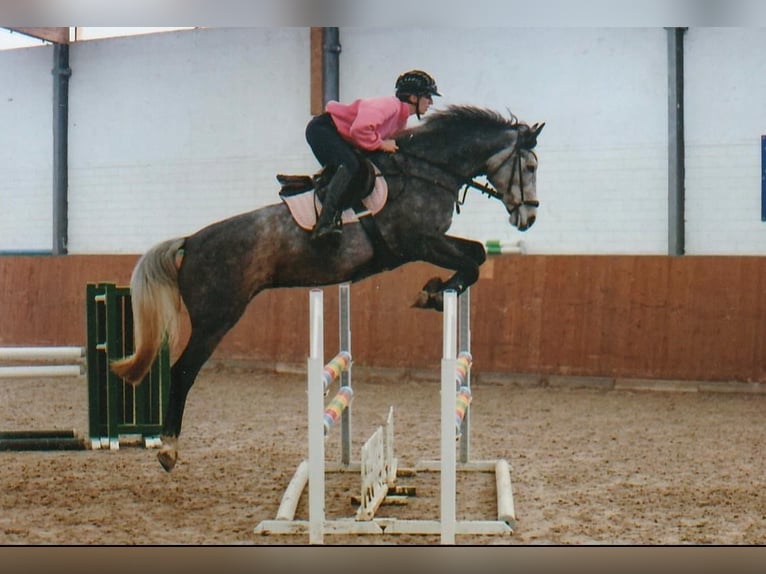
xmin=441 ymin=290 xmax=457 ymax=544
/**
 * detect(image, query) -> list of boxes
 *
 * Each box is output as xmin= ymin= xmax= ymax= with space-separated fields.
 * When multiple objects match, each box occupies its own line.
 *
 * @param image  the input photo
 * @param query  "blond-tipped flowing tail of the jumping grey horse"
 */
xmin=111 ymin=238 xmax=185 ymax=384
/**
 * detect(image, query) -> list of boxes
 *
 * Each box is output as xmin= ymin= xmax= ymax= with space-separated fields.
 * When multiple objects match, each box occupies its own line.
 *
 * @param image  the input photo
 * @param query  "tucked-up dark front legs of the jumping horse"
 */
xmin=412 ymin=235 xmax=487 ymax=311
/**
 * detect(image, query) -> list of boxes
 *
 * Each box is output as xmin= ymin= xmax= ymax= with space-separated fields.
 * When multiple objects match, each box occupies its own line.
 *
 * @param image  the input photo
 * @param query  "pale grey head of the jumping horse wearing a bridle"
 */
xmin=486 ymin=123 xmax=545 ymax=231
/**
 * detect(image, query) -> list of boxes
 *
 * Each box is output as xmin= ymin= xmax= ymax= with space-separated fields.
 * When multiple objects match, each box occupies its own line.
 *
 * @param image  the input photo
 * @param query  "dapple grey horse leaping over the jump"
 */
xmin=111 ymin=106 xmax=545 ymax=472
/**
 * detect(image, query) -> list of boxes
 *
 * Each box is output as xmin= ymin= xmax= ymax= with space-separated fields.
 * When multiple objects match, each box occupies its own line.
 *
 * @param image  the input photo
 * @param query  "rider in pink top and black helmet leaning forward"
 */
xmin=306 ymin=70 xmax=441 ymax=239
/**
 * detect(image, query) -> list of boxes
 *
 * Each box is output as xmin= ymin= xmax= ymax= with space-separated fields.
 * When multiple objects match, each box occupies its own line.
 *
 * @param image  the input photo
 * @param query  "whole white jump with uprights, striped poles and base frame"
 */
xmin=255 ymin=284 xmax=515 ymax=544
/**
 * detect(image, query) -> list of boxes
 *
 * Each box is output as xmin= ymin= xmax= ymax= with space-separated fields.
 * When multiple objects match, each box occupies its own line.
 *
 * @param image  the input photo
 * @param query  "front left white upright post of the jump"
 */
xmin=308 ymin=289 xmax=325 ymax=544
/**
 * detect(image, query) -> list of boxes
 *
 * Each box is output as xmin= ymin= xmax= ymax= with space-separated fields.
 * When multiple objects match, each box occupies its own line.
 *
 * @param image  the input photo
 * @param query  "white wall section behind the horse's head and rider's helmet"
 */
xmin=341 ymin=28 xmax=667 ymax=253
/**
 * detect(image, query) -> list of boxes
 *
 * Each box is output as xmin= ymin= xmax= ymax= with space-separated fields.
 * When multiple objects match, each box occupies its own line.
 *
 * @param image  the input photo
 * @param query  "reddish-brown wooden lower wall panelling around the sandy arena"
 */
xmin=0 ymin=255 xmax=766 ymax=381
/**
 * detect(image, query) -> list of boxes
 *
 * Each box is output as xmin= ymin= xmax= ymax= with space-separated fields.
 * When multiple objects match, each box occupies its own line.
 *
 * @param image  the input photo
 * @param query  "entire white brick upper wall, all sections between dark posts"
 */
xmin=0 ymin=27 xmax=766 ymax=254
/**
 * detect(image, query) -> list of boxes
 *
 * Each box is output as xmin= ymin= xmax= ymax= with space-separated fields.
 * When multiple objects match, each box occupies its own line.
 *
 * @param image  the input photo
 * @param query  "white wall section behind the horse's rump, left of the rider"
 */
xmin=69 ymin=28 xmax=317 ymax=253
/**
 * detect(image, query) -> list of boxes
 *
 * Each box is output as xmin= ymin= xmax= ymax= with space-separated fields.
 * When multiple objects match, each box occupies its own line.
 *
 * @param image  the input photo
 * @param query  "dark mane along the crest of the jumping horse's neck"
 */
xmin=403 ymin=105 xmax=534 ymax=149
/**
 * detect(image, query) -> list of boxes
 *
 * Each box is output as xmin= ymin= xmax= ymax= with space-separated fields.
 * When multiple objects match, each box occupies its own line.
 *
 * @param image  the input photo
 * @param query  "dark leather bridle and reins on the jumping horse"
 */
xmin=393 ymin=145 xmax=540 ymax=214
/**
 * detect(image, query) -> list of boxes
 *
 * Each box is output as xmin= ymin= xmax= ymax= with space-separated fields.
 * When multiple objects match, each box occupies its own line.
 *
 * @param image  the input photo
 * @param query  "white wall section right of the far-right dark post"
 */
xmin=685 ymin=28 xmax=766 ymax=255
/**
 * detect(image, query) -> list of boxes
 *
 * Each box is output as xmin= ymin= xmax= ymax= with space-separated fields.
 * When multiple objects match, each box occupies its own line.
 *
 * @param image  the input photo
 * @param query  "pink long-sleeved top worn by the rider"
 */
xmin=325 ymin=96 xmax=410 ymax=151
